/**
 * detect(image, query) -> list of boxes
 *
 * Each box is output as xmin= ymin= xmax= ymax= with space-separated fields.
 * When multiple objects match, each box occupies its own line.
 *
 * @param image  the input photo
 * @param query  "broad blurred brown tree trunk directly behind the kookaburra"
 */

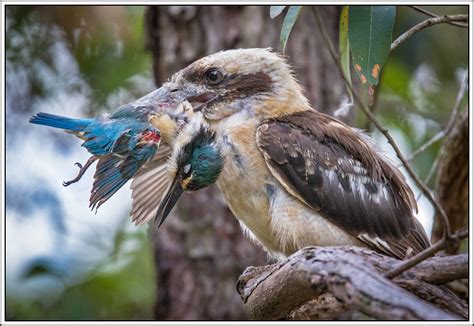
xmin=145 ymin=6 xmax=344 ymax=320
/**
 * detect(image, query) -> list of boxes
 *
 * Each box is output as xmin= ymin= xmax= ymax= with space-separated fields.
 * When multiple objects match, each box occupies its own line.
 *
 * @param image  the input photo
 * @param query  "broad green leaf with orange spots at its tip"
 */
xmin=349 ymin=6 xmax=396 ymax=90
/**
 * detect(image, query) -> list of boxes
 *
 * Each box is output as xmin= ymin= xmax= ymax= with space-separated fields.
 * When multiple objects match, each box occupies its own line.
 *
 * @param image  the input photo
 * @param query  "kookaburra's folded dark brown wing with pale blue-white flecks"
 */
xmin=256 ymin=110 xmax=430 ymax=259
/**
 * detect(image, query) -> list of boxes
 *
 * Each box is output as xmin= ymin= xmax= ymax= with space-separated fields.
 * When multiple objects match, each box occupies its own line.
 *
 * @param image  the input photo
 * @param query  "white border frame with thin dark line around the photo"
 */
xmin=0 ymin=0 xmax=474 ymax=325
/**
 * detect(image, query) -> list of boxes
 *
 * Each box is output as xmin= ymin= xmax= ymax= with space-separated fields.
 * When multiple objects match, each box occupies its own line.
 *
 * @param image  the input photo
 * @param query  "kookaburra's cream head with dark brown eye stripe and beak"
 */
xmin=131 ymin=48 xmax=308 ymax=120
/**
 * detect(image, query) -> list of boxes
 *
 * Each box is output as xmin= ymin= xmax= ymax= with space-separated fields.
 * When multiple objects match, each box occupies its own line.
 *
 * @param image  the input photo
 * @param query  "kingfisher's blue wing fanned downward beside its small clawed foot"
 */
xmin=89 ymin=144 xmax=157 ymax=209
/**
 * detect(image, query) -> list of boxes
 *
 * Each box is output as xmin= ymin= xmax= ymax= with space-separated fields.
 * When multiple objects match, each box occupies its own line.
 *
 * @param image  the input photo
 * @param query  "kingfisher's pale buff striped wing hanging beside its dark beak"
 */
xmin=130 ymin=143 xmax=171 ymax=224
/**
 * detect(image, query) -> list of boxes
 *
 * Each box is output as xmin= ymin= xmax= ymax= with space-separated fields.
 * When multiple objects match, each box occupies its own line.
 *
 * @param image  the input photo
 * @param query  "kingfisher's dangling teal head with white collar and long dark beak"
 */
xmin=156 ymin=113 xmax=224 ymax=225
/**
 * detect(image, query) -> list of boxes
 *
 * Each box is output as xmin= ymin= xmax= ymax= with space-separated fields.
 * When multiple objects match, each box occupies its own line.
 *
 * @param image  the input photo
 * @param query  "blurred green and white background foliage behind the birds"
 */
xmin=5 ymin=6 xmax=468 ymax=320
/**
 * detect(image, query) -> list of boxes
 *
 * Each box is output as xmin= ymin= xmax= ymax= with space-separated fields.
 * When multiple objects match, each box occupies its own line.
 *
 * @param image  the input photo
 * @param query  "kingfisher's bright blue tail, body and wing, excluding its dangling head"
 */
xmin=30 ymin=95 xmax=189 ymax=209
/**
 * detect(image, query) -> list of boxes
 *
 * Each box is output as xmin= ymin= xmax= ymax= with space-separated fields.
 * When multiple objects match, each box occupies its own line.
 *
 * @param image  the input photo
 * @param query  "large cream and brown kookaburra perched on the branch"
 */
xmin=132 ymin=49 xmax=430 ymax=259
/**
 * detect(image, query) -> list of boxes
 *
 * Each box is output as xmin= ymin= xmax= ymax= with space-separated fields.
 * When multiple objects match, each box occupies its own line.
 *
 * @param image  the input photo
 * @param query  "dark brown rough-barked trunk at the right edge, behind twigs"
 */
xmin=431 ymin=110 xmax=469 ymax=253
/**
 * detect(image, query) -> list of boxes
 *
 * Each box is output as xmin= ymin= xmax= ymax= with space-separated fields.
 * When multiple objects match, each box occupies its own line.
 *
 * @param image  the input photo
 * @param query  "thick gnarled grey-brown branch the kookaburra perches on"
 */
xmin=238 ymin=247 xmax=469 ymax=320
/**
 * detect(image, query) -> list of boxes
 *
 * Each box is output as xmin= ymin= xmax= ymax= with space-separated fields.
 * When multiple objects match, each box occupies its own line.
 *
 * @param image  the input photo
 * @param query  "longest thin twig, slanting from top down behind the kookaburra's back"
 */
xmin=311 ymin=7 xmax=452 ymax=239
